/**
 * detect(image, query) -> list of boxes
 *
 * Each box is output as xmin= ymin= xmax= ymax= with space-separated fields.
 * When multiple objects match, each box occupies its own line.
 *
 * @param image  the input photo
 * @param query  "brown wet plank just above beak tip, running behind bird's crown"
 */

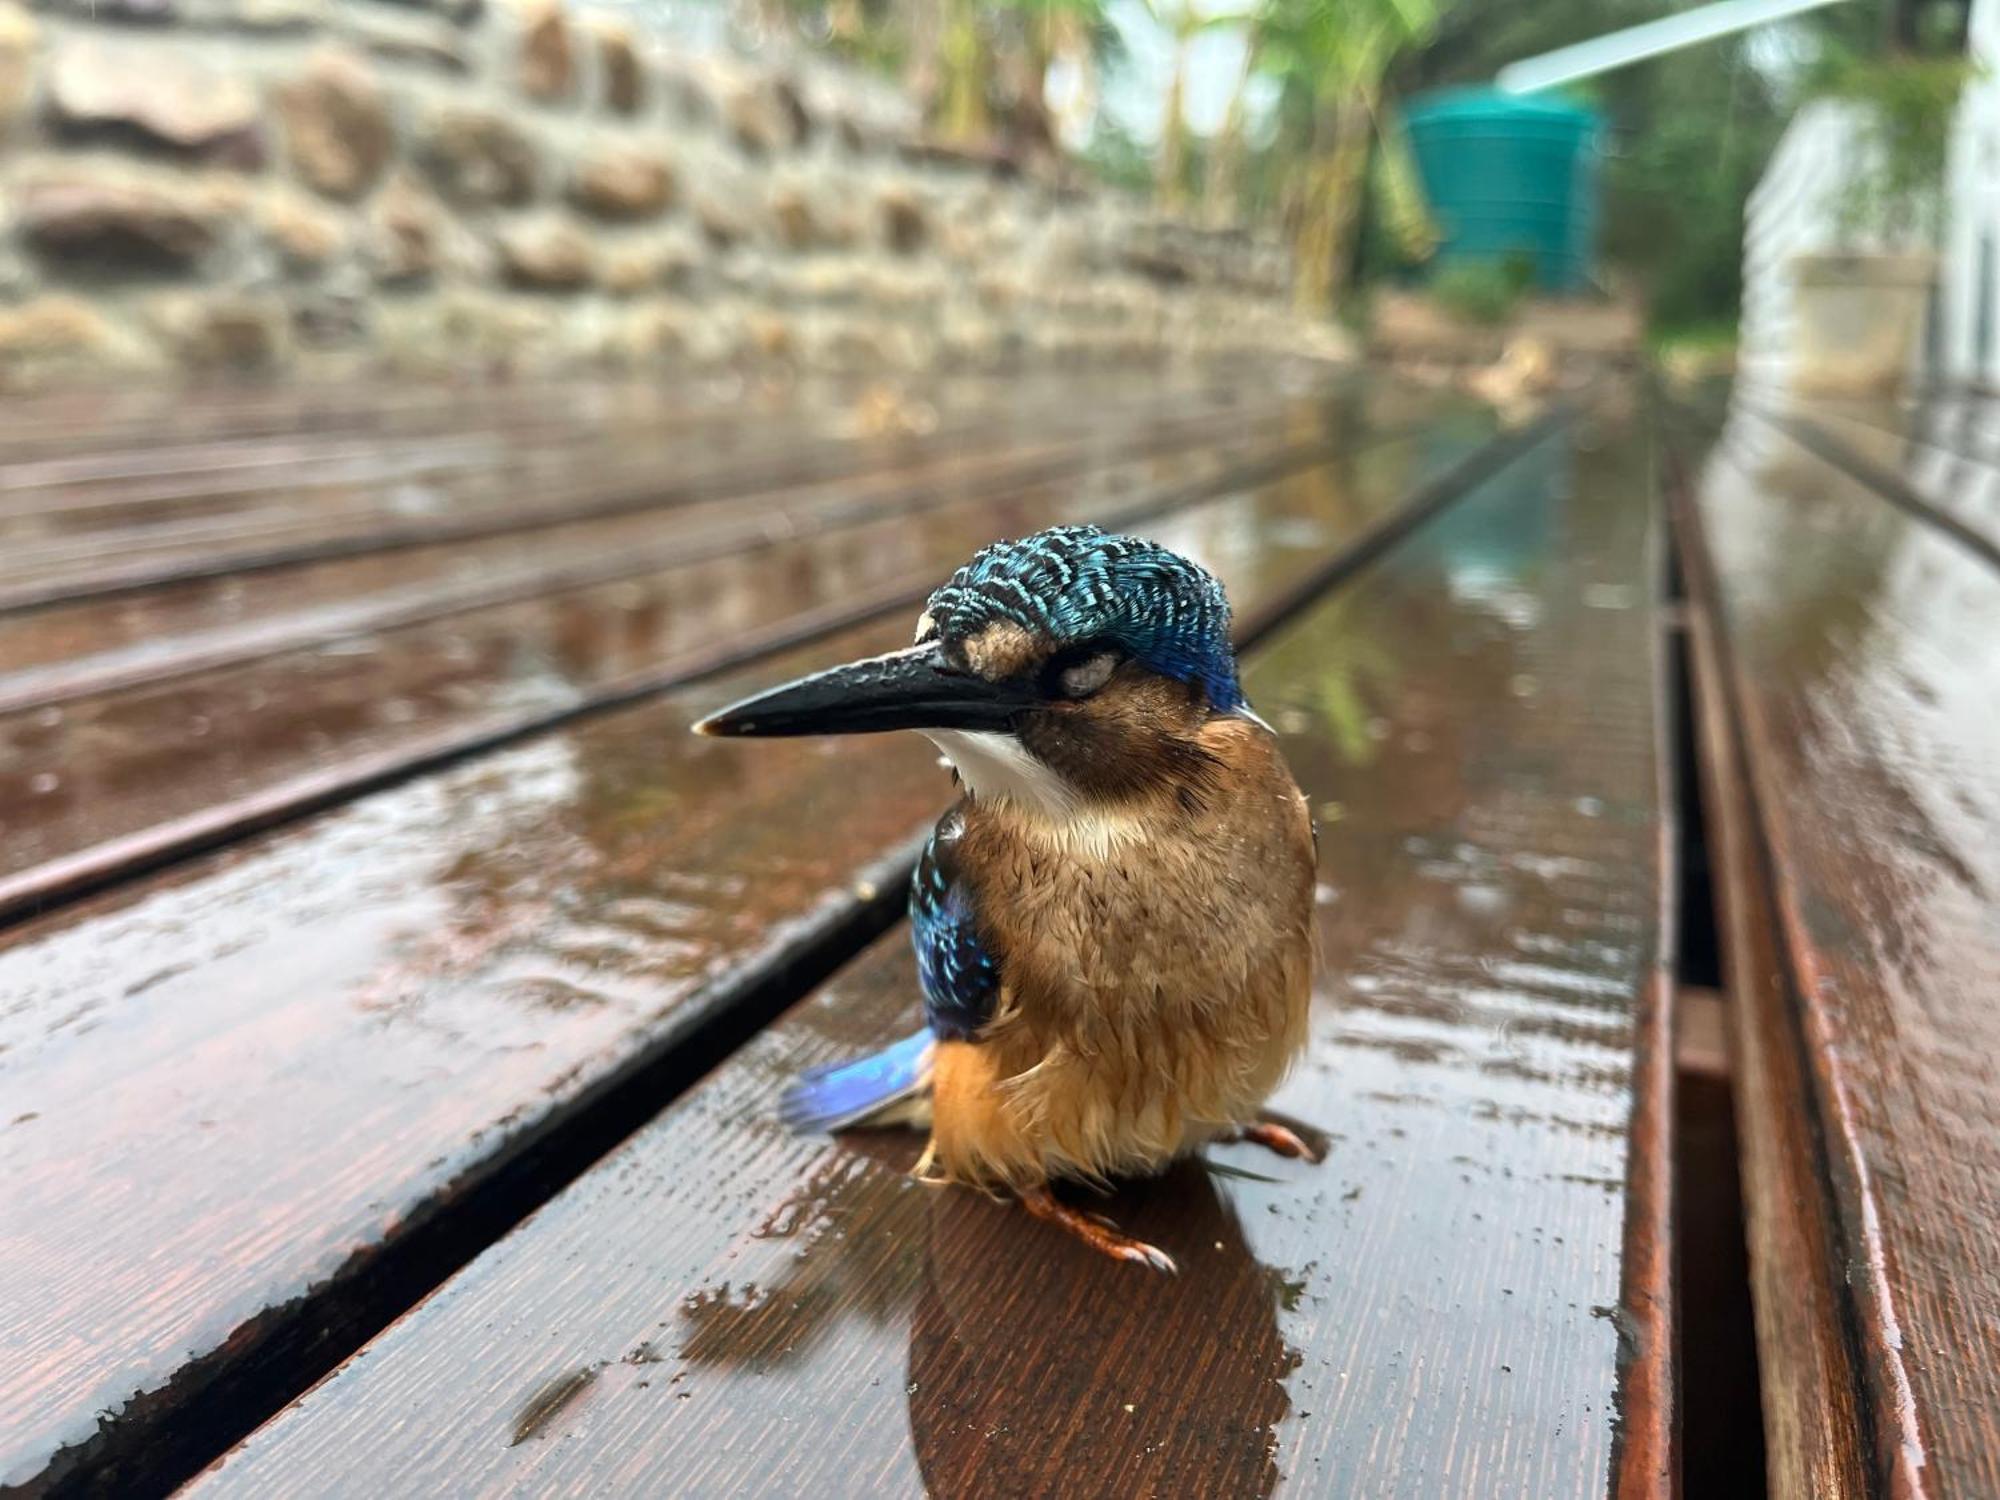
xmin=0 ymin=418 xmax=1326 ymax=892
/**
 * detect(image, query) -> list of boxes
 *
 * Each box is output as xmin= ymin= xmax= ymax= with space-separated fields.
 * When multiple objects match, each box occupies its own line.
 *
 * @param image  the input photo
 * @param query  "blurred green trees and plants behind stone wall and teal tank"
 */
xmin=704 ymin=0 xmax=1968 ymax=342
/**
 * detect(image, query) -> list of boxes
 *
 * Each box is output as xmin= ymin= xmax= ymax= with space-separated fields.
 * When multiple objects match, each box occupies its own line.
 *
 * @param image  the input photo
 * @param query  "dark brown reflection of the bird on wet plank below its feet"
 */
xmin=680 ymin=1132 xmax=1298 ymax=1494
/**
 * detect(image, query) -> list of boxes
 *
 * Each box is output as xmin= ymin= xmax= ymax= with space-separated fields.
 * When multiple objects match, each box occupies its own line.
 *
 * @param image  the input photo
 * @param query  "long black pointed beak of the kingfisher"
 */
xmin=694 ymin=644 xmax=1038 ymax=736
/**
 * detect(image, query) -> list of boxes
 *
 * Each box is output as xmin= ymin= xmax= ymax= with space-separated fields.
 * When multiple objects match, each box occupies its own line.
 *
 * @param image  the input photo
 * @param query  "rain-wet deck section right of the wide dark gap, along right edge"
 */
xmin=1680 ymin=402 xmax=2000 ymax=1496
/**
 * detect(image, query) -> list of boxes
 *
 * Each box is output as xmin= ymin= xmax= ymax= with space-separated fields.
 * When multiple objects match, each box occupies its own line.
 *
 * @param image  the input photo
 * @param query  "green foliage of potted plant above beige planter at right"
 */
xmin=1810 ymin=48 xmax=1972 ymax=240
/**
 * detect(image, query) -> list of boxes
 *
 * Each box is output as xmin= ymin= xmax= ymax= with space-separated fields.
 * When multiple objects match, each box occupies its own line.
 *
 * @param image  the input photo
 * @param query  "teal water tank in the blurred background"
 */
xmin=1404 ymin=88 xmax=1600 ymax=292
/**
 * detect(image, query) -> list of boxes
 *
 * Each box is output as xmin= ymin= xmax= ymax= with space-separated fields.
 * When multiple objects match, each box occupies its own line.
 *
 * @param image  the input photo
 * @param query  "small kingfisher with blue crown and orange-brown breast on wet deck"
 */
xmin=696 ymin=526 xmax=1316 ymax=1272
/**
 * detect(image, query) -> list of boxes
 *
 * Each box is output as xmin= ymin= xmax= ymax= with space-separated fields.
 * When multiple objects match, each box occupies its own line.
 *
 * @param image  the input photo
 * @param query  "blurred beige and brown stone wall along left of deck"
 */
xmin=0 ymin=0 xmax=1332 ymax=386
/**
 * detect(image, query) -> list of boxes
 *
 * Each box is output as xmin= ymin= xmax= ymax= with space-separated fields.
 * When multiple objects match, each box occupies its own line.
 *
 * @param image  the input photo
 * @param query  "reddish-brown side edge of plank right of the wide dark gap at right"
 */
xmin=1676 ymin=462 xmax=1870 ymax=1500
